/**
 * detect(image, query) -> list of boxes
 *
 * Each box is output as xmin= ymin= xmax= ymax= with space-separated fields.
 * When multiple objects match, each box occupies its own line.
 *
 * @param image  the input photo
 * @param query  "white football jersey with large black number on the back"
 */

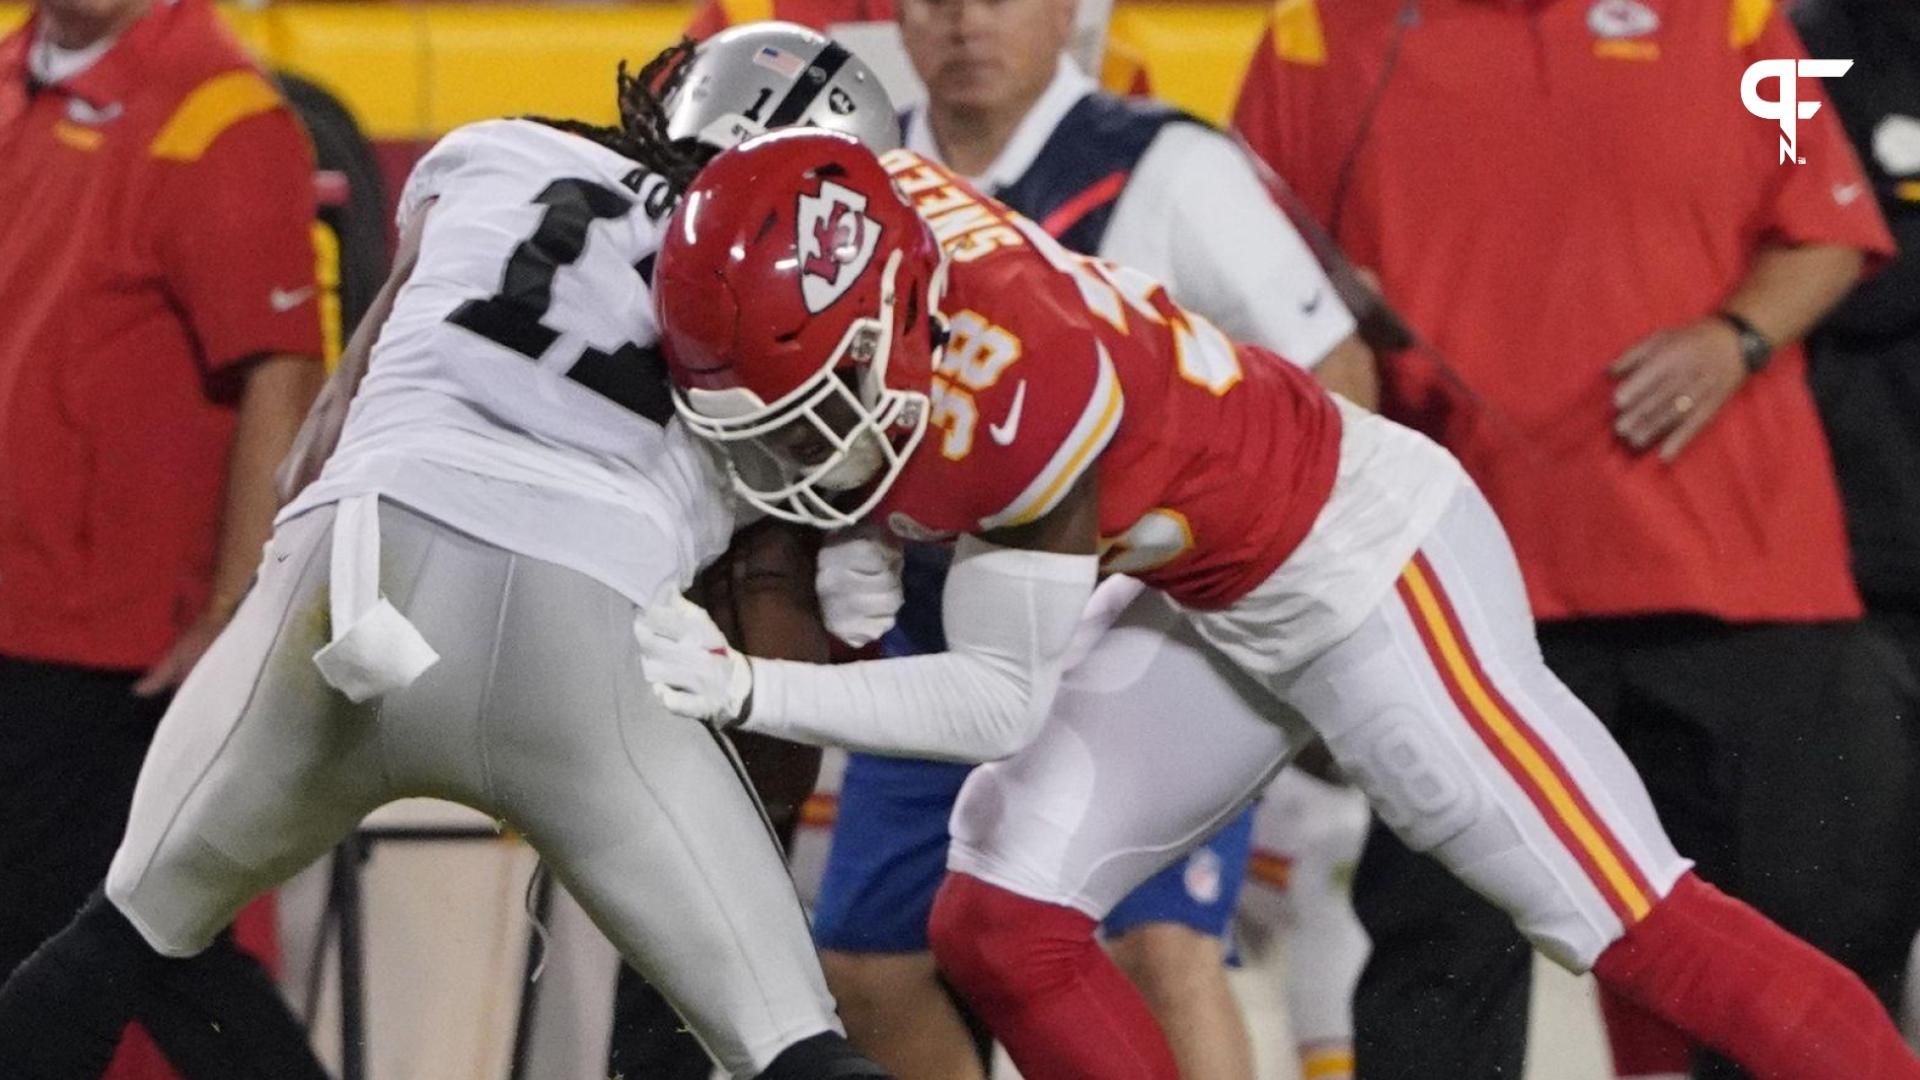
xmin=282 ymin=119 xmax=733 ymax=603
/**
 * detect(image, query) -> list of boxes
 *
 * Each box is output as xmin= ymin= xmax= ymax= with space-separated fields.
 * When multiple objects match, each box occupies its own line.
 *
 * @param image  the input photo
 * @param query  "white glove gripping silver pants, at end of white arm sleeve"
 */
xmin=634 ymin=596 xmax=753 ymax=730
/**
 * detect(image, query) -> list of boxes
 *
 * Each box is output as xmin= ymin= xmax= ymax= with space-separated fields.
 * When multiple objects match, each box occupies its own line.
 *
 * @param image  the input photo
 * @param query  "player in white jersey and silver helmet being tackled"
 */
xmin=0 ymin=23 xmax=913 ymax=1080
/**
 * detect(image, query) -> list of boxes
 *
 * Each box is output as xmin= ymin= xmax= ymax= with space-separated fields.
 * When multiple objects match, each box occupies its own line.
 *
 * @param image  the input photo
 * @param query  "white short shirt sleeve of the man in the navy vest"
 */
xmin=1100 ymin=123 xmax=1354 ymax=367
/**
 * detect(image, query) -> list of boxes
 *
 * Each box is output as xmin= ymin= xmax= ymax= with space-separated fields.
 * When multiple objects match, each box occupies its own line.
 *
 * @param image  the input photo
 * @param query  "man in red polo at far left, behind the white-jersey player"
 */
xmin=0 ymin=0 xmax=323 ymax=1076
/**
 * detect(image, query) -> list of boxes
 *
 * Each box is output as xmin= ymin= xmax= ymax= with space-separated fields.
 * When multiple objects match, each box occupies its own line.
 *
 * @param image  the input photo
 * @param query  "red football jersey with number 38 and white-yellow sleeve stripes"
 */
xmin=881 ymin=150 xmax=1340 ymax=607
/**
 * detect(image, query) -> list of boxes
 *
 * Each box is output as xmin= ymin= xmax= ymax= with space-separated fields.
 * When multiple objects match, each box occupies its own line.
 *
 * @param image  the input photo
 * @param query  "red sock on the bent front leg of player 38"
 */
xmin=927 ymin=872 xmax=1179 ymax=1080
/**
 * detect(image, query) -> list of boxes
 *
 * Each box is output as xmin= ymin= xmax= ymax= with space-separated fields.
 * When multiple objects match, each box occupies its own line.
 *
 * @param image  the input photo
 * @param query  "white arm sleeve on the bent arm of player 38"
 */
xmin=743 ymin=536 xmax=1098 ymax=761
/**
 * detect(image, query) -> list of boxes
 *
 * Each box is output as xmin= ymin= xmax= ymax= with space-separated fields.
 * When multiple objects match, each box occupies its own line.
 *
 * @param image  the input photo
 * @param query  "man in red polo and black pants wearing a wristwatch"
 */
xmin=1236 ymin=0 xmax=1912 ymax=1080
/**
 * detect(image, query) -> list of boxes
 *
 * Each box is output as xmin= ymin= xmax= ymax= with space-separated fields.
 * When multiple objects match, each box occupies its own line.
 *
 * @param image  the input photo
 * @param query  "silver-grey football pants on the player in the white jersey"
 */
xmin=108 ymin=503 xmax=839 ymax=1076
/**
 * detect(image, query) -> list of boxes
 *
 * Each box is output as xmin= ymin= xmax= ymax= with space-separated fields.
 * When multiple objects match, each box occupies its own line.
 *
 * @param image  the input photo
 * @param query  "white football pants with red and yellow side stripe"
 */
xmin=948 ymin=484 xmax=1690 ymax=970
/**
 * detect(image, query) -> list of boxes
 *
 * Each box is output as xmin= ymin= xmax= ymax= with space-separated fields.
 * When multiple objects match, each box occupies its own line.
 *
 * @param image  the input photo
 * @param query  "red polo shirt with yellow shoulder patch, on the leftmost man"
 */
xmin=0 ymin=0 xmax=321 ymax=669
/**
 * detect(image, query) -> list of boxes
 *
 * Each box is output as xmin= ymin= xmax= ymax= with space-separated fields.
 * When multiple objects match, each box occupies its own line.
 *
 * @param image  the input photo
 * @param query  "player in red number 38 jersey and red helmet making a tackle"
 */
xmin=637 ymin=133 xmax=1920 ymax=1080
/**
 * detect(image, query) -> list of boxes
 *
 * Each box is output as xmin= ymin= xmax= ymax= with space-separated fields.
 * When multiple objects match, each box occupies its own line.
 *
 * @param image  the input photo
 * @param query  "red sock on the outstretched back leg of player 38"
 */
xmin=1594 ymin=874 xmax=1920 ymax=1080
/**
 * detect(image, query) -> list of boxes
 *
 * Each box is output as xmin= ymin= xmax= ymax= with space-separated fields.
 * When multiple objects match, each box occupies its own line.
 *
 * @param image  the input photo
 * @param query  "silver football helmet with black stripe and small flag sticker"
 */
xmin=662 ymin=21 xmax=900 ymax=154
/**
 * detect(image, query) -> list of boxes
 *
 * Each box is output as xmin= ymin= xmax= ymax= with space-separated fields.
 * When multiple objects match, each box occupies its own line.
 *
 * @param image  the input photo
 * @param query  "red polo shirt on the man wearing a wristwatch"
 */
xmin=1235 ymin=0 xmax=1891 ymax=621
